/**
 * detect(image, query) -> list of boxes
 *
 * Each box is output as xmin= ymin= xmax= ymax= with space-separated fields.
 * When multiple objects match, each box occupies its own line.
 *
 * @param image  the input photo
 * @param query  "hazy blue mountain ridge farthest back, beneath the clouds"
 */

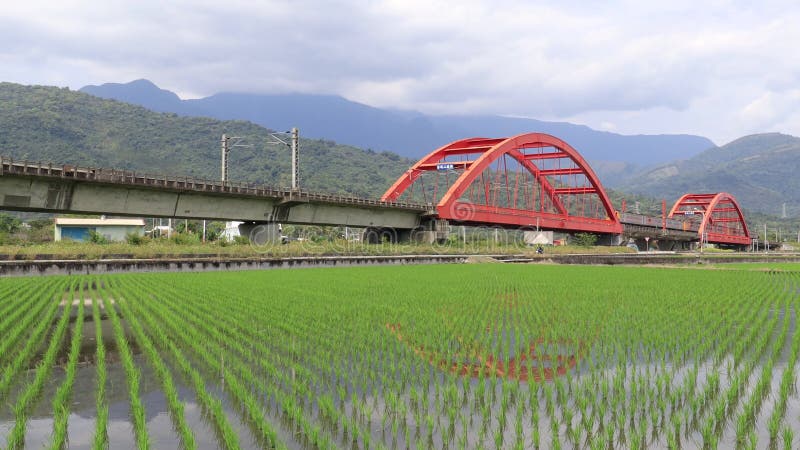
xmin=81 ymin=80 xmax=714 ymax=185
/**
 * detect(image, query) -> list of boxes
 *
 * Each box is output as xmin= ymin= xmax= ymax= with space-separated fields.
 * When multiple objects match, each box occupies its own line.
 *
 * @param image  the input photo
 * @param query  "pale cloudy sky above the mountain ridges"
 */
xmin=0 ymin=0 xmax=800 ymax=144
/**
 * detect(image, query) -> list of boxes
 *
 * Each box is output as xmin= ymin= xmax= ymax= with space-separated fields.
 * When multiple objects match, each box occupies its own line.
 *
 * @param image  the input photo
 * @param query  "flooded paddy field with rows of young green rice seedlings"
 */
xmin=0 ymin=264 xmax=800 ymax=449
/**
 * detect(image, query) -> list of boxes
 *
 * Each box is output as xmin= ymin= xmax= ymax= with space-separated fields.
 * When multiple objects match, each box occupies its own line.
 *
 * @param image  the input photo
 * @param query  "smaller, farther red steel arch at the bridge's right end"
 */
xmin=669 ymin=192 xmax=750 ymax=245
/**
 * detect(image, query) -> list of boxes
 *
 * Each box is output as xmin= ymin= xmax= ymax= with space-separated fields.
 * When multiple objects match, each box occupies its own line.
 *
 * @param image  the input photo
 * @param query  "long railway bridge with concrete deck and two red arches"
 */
xmin=0 ymin=133 xmax=751 ymax=248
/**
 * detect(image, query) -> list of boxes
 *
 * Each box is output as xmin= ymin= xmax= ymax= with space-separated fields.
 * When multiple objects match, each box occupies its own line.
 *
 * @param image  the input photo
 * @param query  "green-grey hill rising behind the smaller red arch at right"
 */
xmin=620 ymin=133 xmax=800 ymax=217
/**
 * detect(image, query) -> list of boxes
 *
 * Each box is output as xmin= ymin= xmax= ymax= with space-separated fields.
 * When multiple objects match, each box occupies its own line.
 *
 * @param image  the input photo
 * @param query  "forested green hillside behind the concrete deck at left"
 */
xmin=0 ymin=83 xmax=413 ymax=198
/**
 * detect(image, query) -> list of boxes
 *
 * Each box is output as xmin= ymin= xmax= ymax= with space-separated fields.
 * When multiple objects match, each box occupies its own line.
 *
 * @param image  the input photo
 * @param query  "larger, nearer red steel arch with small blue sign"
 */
xmin=381 ymin=133 xmax=622 ymax=234
